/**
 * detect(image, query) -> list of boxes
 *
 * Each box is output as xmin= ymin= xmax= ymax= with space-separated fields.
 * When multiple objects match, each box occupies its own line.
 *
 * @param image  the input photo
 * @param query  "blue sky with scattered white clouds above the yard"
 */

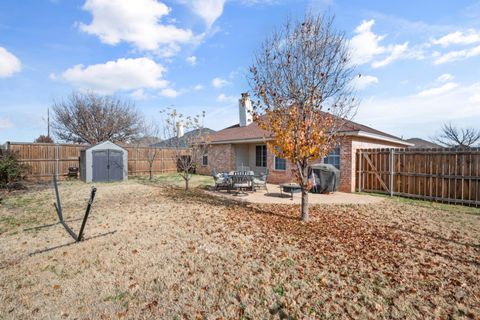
xmin=0 ymin=0 xmax=480 ymax=143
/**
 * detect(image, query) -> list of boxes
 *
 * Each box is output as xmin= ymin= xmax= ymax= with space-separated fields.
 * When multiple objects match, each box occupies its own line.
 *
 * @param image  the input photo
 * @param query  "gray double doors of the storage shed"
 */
xmin=92 ymin=150 xmax=123 ymax=182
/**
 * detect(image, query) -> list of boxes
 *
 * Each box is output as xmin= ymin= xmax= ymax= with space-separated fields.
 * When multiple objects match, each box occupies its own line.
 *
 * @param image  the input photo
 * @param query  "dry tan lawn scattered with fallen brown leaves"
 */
xmin=0 ymin=175 xmax=480 ymax=319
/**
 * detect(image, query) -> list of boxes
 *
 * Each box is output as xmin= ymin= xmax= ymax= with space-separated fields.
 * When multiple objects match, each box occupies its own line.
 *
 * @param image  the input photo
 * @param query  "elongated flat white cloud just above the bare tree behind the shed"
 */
xmin=62 ymin=58 xmax=169 ymax=94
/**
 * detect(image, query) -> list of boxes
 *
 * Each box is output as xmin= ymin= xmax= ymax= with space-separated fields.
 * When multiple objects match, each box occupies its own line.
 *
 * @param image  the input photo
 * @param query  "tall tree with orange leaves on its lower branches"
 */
xmin=250 ymin=14 xmax=357 ymax=221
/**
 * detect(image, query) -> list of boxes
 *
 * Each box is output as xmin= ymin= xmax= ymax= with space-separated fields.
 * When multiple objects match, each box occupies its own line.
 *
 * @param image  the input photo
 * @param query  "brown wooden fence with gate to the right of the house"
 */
xmin=356 ymin=148 xmax=480 ymax=206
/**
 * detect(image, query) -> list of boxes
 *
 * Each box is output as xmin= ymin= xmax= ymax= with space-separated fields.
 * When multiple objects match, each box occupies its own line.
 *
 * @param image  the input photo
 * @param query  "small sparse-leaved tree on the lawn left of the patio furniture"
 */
xmin=161 ymin=108 xmax=208 ymax=191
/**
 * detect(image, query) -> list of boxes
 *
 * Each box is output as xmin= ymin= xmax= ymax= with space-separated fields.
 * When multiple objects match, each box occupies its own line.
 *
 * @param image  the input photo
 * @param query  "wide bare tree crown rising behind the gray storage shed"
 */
xmin=52 ymin=92 xmax=142 ymax=144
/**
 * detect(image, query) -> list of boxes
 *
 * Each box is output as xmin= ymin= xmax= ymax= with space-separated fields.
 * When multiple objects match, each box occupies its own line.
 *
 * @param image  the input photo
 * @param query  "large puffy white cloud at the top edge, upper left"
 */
xmin=79 ymin=0 xmax=195 ymax=56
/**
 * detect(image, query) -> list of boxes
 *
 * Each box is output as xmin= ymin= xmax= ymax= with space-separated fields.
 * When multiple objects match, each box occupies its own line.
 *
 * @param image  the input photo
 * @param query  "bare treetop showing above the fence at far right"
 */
xmin=432 ymin=123 xmax=480 ymax=148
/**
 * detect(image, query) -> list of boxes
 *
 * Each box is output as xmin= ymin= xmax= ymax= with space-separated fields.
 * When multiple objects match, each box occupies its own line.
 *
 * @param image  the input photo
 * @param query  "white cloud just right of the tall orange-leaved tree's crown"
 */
xmin=350 ymin=19 xmax=412 ymax=68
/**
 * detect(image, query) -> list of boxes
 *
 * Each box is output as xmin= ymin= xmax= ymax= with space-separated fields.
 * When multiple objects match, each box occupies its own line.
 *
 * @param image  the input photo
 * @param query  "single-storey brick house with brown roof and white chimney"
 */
xmin=198 ymin=94 xmax=412 ymax=192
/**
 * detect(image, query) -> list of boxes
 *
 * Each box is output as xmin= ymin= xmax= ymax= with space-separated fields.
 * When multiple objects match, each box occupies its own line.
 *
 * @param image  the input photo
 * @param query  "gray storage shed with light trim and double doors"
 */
xmin=80 ymin=141 xmax=128 ymax=182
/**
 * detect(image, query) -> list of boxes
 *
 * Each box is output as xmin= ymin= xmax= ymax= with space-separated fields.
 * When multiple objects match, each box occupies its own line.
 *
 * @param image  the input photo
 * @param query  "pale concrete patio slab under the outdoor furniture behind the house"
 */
xmin=207 ymin=184 xmax=384 ymax=204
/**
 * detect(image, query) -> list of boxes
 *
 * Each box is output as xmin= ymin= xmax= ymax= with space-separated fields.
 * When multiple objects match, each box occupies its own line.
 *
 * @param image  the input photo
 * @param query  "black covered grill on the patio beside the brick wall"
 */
xmin=310 ymin=163 xmax=340 ymax=193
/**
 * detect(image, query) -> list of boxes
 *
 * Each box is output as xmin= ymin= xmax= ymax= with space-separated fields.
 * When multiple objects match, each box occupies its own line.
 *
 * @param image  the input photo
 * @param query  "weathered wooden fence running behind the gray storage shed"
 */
xmin=7 ymin=142 xmax=184 ymax=180
